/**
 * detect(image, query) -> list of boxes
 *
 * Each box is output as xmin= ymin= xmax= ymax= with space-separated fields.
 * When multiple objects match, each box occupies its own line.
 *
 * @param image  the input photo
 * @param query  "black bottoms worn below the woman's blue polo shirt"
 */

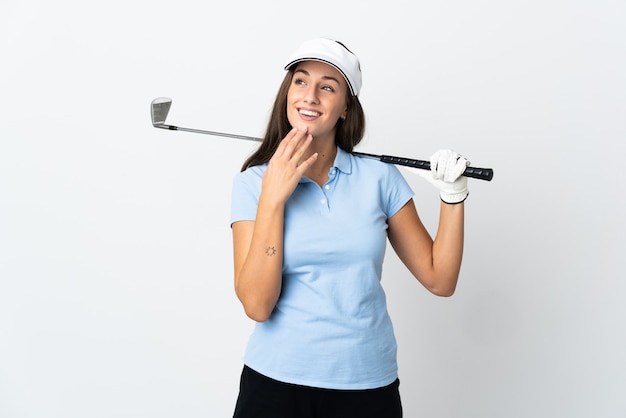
xmin=233 ymin=366 xmax=402 ymax=418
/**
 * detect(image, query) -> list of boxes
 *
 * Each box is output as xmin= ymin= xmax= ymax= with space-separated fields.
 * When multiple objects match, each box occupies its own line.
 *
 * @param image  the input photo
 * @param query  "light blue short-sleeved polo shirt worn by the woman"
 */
xmin=231 ymin=148 xmax=413 ymax=389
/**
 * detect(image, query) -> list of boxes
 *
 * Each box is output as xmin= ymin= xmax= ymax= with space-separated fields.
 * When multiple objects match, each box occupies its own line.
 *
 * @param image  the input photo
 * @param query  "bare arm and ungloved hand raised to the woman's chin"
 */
xmin=232 ymin=130 xmax=317 ymax=322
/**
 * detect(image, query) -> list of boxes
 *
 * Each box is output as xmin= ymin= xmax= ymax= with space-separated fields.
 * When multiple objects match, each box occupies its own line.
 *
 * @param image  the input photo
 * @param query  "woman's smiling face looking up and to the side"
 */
xmin=287 ymin=61 xmax=348 ymax=141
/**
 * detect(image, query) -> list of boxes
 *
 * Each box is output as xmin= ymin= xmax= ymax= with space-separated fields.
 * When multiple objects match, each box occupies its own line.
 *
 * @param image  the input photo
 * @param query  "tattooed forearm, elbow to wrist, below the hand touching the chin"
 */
xmin=235 ymin=198 xmax=284 ymax=322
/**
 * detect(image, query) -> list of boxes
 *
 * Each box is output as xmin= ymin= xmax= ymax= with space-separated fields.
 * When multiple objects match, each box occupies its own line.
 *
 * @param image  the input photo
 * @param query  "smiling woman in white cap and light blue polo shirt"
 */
xmin=231 ymin=39 xmax=468 ymax=418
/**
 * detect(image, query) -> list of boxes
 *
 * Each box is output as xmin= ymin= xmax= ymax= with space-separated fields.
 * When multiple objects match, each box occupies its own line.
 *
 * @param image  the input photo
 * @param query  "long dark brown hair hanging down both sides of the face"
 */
xmin=241 ymin=66 xmax=365 ymax=171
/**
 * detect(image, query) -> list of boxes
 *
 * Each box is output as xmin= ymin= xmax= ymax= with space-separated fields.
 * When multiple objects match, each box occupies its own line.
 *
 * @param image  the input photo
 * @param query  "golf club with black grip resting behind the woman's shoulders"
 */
xmin=150 ymin=97 xmax=493 ymax=181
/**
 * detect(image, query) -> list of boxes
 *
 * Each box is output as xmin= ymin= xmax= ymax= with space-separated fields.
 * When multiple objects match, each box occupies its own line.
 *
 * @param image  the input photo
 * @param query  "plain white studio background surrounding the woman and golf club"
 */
xmin=0 ymin=0 xmax=626 ymax=418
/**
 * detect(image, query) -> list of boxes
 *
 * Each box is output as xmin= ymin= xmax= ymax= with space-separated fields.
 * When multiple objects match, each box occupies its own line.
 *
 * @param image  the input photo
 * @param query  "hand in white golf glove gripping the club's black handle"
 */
xmin=404 ymin=149 xmax=469 ymax=204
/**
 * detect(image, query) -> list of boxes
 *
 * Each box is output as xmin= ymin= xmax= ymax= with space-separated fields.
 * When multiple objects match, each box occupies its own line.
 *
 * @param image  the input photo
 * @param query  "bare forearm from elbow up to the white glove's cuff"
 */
xmin=432 ymin=202 xmax=465 ymax=296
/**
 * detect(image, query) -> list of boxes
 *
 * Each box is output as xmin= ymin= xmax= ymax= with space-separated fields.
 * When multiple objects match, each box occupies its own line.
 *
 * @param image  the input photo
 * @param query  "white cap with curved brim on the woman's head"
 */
xmin=285 ymin=38 xmax=362 ymax=96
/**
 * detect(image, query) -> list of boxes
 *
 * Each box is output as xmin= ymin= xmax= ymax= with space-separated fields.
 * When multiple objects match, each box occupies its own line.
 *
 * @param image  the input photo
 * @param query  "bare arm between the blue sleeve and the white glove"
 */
xmin=388 ymin=199 xmax=465 ymax=296
